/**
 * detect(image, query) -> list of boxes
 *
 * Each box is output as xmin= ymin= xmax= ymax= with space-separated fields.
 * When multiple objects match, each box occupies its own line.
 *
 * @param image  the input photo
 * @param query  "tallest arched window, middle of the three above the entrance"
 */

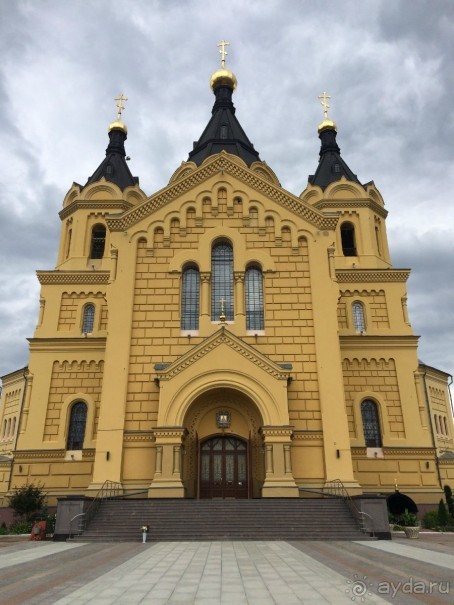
xmin=211 ymin=242 xmax=234 ymax=321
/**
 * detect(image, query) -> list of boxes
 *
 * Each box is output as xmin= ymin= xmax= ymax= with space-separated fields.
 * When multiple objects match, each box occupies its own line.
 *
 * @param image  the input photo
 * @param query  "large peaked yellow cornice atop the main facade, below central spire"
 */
xmin=106 ymin=152 xmax=338 ymax=231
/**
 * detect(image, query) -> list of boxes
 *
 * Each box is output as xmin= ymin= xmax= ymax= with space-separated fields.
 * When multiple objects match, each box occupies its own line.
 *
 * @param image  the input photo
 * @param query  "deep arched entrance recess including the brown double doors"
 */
xmin=182 ymin=388 xmax=265 ymax=498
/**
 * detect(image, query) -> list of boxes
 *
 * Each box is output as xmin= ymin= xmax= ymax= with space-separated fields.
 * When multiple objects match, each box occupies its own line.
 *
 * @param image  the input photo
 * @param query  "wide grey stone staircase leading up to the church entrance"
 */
xmin=72 ymin=498 xmax=369 ymax=542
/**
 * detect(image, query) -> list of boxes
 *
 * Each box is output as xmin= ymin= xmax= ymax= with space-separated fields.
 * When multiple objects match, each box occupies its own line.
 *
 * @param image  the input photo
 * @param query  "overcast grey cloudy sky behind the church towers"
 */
xmin=0 ymin=0 xmax=454 ymax=390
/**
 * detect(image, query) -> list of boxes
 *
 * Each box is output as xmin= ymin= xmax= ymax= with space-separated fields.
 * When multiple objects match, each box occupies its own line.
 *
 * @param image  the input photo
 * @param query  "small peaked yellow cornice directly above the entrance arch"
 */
xmin=155 ymin=327 xmax=291 ymax=380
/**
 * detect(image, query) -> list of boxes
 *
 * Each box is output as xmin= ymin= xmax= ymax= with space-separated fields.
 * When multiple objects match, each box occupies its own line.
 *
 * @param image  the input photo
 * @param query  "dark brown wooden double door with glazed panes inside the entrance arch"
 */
xmin=199 ymin=435 xmax=249 ymax=498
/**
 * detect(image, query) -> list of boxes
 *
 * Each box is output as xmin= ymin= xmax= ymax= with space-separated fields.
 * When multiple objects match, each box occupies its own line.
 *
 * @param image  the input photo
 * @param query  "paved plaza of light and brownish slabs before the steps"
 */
xmin=0 ymin=534 xmax=454 ymax=605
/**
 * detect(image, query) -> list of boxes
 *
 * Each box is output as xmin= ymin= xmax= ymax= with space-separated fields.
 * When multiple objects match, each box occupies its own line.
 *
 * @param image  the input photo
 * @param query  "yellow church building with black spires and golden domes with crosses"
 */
xmin=0 ymin=46 xmax=454 ymax=507
